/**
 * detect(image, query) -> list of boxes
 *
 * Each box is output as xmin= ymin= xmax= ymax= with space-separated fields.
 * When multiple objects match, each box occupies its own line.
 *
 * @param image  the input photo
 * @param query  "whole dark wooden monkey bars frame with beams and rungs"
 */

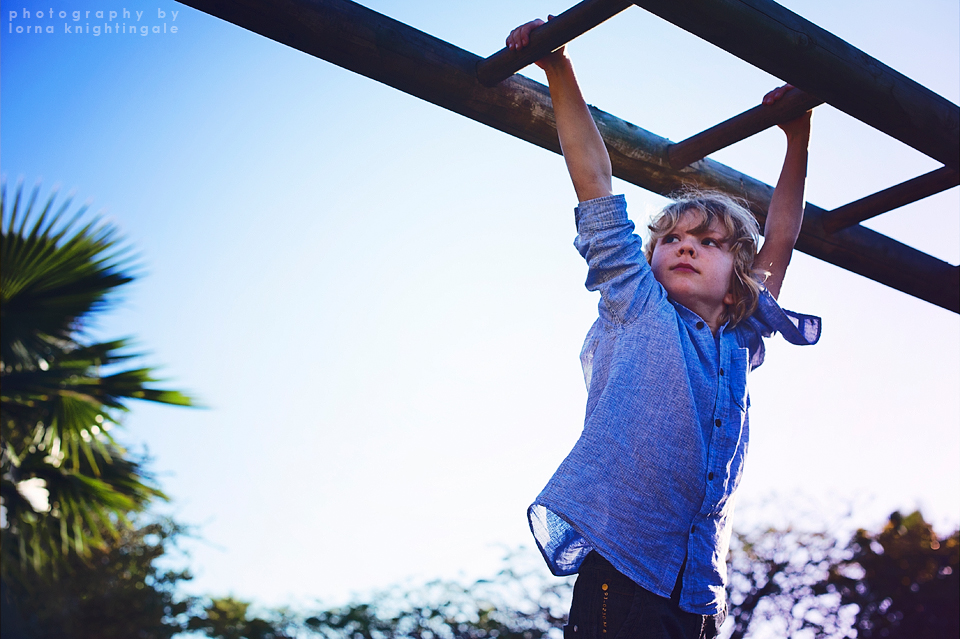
xmin=180 ymin=0 xmax=960 ymax=313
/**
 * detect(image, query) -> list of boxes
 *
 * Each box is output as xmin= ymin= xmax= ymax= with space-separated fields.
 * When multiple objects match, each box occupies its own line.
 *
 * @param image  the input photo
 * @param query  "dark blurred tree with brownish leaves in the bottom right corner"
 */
xmin=822 ymin=511 xmax=960 ymax=639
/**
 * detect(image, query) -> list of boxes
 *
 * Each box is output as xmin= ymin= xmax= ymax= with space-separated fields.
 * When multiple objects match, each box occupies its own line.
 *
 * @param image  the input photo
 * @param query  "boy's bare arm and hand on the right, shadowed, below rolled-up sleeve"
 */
xmin=753 ymin=84 xmax=812 ymax=299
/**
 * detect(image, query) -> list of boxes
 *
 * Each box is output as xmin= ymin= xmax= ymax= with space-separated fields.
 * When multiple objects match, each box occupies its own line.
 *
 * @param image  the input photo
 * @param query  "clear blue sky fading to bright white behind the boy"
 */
xmin=0 ymin=0 xmax=960 ymax=616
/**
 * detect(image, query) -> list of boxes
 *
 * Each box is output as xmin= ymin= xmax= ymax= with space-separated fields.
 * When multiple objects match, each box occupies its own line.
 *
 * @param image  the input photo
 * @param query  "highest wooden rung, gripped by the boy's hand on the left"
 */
xmin=477 ymin=0 xmax=633 ymax=87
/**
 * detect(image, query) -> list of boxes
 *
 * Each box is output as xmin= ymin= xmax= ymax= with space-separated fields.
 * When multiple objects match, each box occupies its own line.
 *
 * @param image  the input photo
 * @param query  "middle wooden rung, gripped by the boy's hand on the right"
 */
xmin=667 ymin=89 xmax=823 ymax=169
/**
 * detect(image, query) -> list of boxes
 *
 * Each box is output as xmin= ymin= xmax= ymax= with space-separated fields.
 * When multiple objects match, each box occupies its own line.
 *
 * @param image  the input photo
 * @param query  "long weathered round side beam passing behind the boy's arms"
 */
xmin=176 ymin=0 xmax=960 ymax=312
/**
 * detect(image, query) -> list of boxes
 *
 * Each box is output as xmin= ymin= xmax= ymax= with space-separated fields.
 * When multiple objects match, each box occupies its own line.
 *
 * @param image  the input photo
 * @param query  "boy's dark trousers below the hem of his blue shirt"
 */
xmin=563 ymin=552 xmax=717 ymax=639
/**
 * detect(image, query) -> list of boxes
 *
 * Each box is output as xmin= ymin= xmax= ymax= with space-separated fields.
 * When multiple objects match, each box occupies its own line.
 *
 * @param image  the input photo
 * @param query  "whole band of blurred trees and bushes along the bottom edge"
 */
xmin=4 ymin=513 xmax=960 ymax=639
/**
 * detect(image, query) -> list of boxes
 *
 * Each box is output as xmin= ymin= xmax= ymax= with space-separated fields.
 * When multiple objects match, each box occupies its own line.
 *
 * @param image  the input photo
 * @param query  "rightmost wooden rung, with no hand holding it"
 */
xmin=823 ymin=166 xmax=960 ymax=233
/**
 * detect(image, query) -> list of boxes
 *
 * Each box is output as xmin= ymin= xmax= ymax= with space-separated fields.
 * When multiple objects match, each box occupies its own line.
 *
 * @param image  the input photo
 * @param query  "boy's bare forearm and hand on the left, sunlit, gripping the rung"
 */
xmin=507 ymin=20 xmax=613 ymax=202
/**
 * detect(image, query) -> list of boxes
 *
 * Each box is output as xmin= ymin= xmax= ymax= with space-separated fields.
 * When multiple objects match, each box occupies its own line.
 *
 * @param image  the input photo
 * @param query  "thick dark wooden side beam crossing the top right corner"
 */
xmin=636 ymin=0 xmax=960 ymax=169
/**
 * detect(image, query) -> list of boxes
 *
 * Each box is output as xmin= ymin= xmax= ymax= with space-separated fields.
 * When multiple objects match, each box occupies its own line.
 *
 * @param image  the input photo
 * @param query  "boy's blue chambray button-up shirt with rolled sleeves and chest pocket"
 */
xmin=528 ymin=195 xmax=820 ymax=615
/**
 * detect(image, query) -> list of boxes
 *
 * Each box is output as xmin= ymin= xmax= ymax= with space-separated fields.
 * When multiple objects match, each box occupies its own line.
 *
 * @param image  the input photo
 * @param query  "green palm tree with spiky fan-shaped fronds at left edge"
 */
xmin=0 ymin=184 xmax=191 ymax=581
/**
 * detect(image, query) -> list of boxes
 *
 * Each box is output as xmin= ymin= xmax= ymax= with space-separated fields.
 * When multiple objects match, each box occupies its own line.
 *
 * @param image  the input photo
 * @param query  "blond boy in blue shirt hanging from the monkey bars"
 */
xmin=507 ymin=20 xmax=820 ymax=639
